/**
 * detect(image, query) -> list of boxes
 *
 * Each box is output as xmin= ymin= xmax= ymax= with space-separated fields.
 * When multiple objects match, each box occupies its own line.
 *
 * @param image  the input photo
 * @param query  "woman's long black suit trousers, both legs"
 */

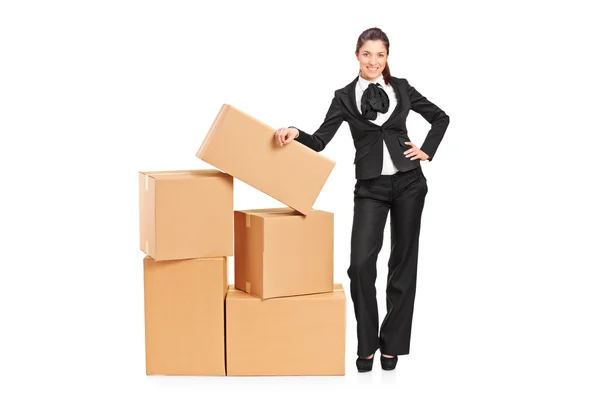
xmin=348 ymin=166 xmax=428 ymax=357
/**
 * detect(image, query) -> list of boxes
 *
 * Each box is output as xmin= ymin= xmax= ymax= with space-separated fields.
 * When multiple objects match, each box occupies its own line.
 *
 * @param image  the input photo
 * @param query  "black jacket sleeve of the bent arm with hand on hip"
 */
xmin=407 ymin=82 xmax=450 ymax=161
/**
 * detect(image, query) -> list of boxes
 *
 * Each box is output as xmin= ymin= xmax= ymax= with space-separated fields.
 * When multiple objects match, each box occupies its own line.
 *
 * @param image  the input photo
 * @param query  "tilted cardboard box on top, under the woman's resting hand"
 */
xmin=196 ymin=104 xmax=335 ymax=214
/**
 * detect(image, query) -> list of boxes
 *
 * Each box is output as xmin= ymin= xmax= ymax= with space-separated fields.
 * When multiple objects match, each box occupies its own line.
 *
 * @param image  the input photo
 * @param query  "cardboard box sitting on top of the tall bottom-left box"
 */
xmin=139 ymin=169 xmax=233 ymax=261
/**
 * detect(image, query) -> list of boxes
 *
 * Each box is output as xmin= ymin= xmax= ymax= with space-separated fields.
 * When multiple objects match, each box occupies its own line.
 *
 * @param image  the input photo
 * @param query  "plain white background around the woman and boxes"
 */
xmin=0 ymin=1 xmax=600 ymax=399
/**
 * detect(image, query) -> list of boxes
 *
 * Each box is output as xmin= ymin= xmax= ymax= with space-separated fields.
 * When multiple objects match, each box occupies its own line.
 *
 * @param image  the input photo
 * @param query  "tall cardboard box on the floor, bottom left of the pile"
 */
xmin=144 ymin=256 xmax=228 ymax=376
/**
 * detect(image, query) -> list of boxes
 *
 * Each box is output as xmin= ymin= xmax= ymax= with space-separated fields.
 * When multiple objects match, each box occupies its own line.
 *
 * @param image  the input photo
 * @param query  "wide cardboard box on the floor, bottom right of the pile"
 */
xmin=225 ymin=284 xmax=346 ymax=376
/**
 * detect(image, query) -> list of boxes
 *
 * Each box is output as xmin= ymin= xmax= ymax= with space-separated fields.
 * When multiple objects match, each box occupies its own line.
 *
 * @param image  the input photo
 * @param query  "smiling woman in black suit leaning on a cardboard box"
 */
xmin=274 ymin=28 xmax=450 ymax=372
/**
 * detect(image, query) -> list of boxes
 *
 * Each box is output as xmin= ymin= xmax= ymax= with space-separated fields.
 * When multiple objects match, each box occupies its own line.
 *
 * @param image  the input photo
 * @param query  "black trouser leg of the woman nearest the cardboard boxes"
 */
xmin=348 ymin=176 xmax=391 ymax=357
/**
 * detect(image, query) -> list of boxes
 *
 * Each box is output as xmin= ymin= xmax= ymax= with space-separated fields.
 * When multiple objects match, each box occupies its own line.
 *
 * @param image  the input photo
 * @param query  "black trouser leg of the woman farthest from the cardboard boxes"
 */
xmin=379 ymin=168 xmax=428 ymax=355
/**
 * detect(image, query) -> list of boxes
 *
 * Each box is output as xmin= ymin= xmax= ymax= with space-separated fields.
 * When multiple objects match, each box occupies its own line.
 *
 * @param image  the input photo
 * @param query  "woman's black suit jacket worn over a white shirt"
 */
xmin=294 ymin=76 xmax=450 ymax=179
